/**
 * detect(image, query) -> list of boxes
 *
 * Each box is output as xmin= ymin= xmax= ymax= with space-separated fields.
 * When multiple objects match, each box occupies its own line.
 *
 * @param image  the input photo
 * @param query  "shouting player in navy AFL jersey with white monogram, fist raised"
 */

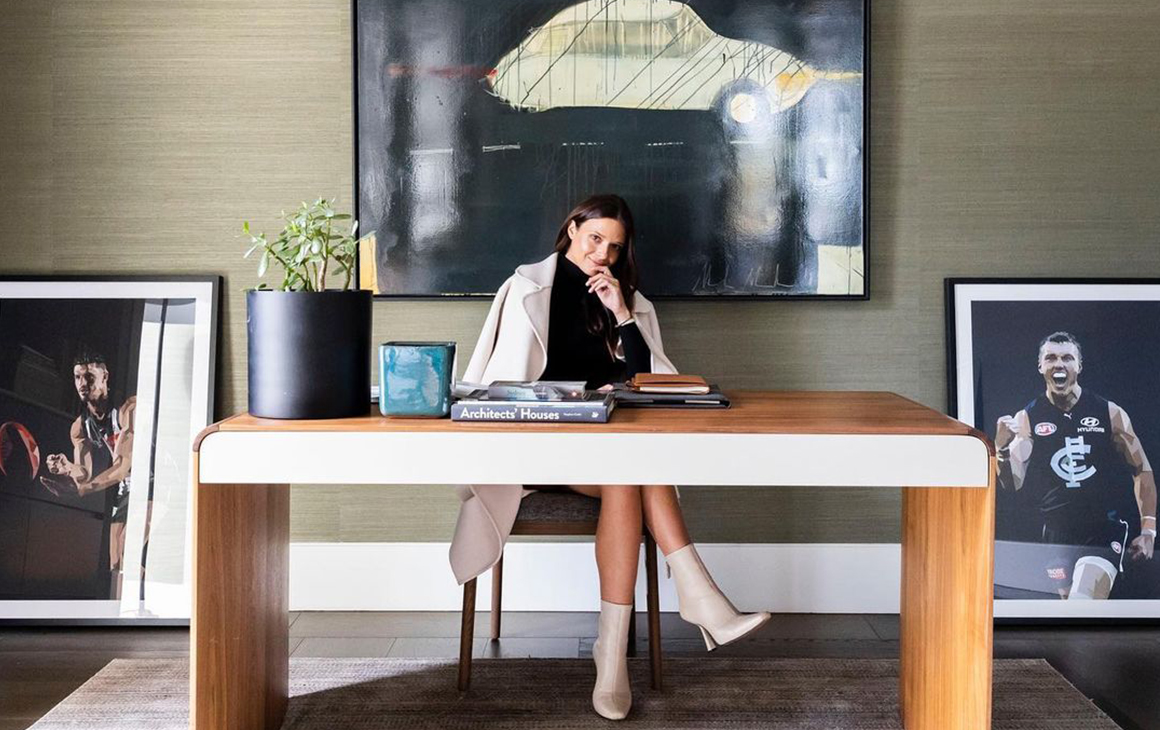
xmin=995 ymin=332 xmax=1157 ymax=599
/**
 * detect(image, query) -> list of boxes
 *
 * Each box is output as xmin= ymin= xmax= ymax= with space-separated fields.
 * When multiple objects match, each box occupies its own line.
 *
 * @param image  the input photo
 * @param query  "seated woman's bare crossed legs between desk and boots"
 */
xmin=568 ymin=484 xmax=690 ymax=603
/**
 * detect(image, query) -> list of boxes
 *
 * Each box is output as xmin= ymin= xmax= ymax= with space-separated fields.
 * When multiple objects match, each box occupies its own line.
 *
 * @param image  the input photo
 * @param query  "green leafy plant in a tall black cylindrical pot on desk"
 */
xmin=241 ymin=197 xmax=371 ymax=418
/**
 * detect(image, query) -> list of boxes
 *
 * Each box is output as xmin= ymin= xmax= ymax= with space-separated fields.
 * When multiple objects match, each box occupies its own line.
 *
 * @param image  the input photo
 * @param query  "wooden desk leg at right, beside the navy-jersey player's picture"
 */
xmin=899 ymin=475 xmax=995 ymax=730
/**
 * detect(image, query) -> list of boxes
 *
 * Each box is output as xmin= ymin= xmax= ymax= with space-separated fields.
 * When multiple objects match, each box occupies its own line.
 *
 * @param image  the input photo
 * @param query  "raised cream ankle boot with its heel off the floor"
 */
xmin=665 ymin=542 xmax=769 ymax=651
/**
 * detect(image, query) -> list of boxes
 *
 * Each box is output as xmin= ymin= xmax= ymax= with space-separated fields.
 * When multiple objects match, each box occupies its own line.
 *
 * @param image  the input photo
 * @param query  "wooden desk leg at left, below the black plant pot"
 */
xmin=189 ymin=467 xmax=290 ymax=730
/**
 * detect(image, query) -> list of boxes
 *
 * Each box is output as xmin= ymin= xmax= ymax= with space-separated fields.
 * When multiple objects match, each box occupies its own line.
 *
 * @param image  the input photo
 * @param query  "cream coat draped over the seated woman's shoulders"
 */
xmin=450 ymin=253 xmax=676 ymax=584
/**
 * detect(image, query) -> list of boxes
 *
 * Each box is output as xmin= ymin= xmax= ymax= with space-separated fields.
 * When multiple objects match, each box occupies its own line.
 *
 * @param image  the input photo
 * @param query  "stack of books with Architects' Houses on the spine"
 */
xmin=451 ymin=381 xmax=616 ymax=424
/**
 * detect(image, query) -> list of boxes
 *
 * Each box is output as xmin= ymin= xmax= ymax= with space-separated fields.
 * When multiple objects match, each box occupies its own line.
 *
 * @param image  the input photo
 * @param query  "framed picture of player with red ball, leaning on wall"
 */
xmin=0 ymin=276 xmax=220 ymax=624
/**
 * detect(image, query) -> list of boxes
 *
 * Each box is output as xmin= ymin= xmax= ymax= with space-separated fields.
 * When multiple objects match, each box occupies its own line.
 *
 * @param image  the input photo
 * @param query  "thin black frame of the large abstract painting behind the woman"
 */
xmin=350 ymin=0 xmax=872 ymax=302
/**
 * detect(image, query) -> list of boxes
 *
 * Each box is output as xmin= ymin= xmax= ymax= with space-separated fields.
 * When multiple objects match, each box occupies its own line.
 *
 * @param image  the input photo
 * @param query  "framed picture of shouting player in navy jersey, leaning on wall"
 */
xmin=947 ymin=279 xmax=1160 ymax=619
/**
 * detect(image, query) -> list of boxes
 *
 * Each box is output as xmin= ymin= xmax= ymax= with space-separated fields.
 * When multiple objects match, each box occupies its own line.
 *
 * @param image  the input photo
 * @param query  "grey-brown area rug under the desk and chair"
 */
xmin=32 ymin=658 xmax=1117 ymax=730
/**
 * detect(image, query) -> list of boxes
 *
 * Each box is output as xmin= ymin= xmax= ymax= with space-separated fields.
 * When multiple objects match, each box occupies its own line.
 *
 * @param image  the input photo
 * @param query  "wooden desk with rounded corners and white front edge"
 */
xmin=190 ymin=391 xmax=995 ymax=730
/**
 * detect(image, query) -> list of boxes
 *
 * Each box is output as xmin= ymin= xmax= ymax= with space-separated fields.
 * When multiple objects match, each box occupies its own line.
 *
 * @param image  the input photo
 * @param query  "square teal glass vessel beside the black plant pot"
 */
xmin=378 ymin=342 xmax=455 ymax=418
